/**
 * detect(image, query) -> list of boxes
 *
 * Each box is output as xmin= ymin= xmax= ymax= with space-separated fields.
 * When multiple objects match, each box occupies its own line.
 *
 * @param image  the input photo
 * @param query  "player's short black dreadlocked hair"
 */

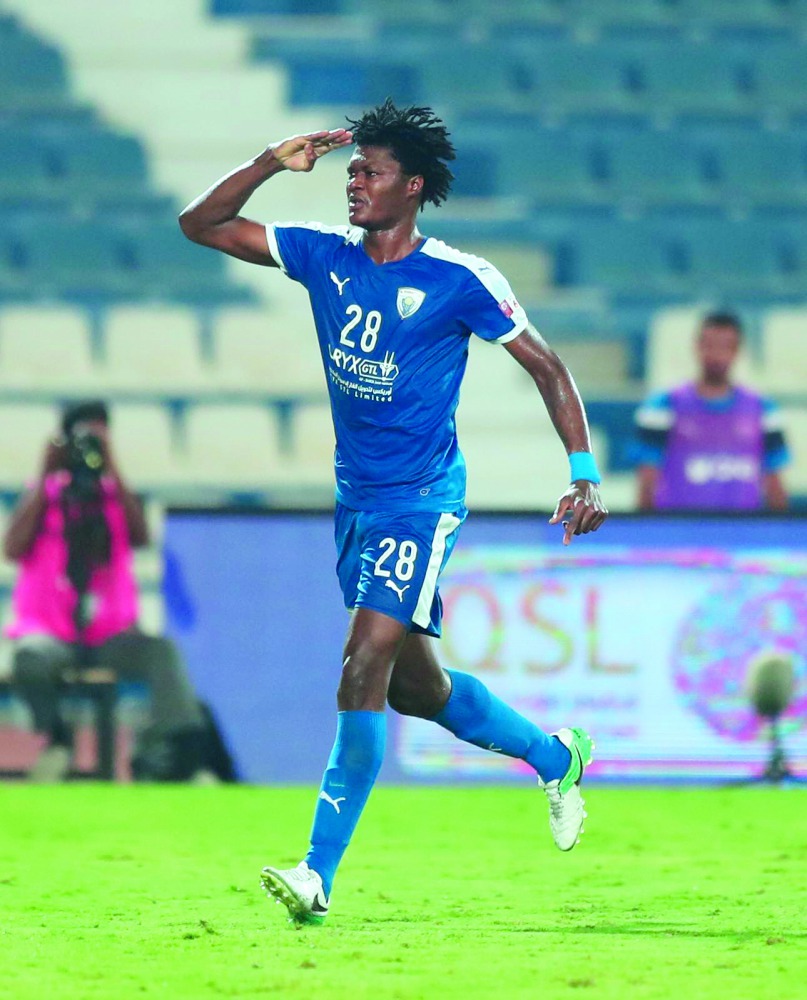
xmin=348 ymin=97 xmax=457 ymax=210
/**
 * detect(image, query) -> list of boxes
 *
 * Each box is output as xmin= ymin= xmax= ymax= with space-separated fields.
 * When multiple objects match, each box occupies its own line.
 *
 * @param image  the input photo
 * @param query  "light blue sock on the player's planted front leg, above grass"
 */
xmin=305 ymin=712 xmax=387 ymax=896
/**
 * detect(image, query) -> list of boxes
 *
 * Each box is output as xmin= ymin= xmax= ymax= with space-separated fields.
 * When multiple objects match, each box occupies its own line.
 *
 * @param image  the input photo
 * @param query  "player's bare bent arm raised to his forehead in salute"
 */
xmin=179 ymin=128 xmax=353 ymax=267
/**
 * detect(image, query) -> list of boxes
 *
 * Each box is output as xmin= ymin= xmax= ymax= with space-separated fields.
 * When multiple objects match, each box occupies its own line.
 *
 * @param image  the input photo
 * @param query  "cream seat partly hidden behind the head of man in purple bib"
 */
xmin=645 ymin=305 xmax=759 ymax=392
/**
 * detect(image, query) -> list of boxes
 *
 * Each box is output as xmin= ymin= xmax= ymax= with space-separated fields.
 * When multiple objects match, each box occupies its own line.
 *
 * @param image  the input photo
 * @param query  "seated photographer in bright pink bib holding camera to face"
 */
xmin=4 ymin=401 xmax=215 ymax=781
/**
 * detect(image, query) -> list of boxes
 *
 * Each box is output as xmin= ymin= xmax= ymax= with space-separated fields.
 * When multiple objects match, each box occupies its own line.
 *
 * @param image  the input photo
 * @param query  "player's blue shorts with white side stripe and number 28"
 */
xmin=334 ymin=503 xmax=468 ymax=636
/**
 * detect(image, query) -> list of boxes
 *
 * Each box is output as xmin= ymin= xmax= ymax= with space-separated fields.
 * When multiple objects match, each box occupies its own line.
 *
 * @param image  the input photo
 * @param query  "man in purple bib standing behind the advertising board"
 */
xmin=635 ymin=312 xmax=789 ymax=510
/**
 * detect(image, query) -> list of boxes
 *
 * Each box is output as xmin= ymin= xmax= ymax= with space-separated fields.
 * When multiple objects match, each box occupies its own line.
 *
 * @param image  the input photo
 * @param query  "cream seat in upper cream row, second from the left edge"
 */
xmin=103 ymin=306 xmax=211 ymax=395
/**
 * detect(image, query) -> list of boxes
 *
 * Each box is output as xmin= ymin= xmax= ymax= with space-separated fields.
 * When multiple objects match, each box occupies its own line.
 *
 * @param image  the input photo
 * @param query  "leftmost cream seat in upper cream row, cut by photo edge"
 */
xmin=0 ymin=306 xmax=99 ymax=395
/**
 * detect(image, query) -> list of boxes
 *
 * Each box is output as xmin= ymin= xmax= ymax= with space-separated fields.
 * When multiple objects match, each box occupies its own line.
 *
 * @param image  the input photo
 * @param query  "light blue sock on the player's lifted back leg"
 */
xmin=432 ymin=670 xmax=571 ymax=781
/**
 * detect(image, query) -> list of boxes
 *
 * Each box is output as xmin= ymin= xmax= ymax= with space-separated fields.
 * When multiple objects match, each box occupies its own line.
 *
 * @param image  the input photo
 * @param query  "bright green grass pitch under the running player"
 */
xmin=0 ymin=784 xmax=807 ymax=1000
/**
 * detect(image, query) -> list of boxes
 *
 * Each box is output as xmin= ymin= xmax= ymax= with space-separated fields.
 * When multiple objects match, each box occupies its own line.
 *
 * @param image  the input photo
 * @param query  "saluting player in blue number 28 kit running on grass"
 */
xmin=180 ymin=99 xmax=607 ymax=923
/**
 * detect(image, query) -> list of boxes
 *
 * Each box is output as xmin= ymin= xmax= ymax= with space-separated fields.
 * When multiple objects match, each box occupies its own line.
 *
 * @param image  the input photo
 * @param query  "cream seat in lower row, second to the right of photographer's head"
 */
xmin=177 ymin=403 xmax=287 ymax=492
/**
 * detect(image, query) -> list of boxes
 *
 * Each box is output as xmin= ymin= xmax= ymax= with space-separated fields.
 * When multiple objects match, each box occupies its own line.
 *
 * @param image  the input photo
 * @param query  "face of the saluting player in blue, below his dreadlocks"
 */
xmin=347 ymin=146 xmax=422 ymax=230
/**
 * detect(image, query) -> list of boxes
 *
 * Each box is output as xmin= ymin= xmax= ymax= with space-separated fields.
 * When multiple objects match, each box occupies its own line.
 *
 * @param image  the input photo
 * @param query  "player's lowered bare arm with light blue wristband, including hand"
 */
xmin=504 ymin=323 xmax=608 ymax=545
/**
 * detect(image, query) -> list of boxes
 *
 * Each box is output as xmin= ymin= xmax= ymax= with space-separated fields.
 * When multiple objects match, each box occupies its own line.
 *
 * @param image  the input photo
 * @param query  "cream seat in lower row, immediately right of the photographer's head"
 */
xmin=110 ymin=403 xmax=177 ymax=491
